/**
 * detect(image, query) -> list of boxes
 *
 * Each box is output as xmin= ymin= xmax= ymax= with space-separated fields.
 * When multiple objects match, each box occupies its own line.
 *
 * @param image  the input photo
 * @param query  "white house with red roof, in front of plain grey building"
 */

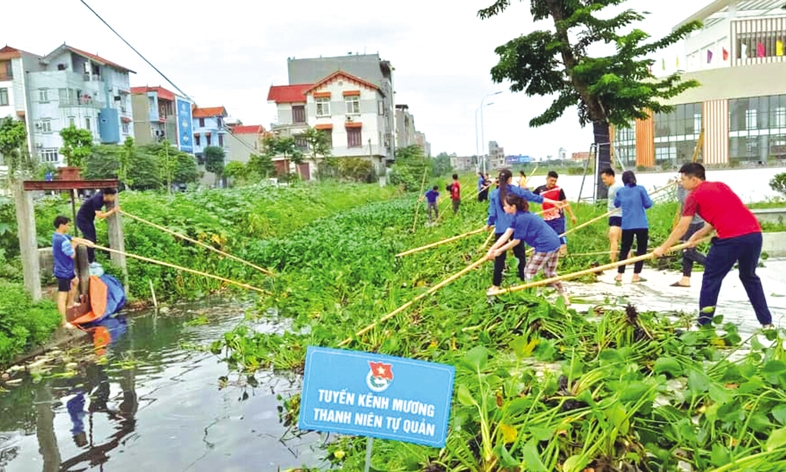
xmin=268 ymin=71 xmax=390 ymax=178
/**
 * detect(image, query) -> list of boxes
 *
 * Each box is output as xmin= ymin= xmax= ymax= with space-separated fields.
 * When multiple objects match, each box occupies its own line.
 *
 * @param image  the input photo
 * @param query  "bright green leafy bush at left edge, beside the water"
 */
xmin=0 ymin=279 xmax=61 ymax=365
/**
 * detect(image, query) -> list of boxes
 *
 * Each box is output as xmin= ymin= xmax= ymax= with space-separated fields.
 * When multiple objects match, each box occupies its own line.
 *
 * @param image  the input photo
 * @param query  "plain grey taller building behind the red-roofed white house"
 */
xmin=287 ymin=54 xmax=396 ymax=164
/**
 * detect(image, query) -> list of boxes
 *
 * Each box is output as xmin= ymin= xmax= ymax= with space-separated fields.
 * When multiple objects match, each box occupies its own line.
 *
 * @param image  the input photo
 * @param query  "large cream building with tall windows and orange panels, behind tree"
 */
xmin=612 ymin=0 xmax=786 ymax=168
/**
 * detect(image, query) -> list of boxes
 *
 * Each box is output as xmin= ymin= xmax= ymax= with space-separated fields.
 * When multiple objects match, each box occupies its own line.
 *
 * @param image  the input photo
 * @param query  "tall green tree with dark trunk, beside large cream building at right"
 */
xmin=478 ymin=0 xmax=701 ymax=198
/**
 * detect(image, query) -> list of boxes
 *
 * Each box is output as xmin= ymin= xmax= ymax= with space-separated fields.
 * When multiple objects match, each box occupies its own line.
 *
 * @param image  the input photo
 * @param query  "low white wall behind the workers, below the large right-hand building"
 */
xmin=529 ymin=167 xmax=786 ymax=203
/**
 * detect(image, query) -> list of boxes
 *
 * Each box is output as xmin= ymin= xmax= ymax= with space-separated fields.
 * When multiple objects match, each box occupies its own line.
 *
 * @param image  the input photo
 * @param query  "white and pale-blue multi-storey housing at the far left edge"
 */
xmin=0 ymin=44 xmax=134 ymax=165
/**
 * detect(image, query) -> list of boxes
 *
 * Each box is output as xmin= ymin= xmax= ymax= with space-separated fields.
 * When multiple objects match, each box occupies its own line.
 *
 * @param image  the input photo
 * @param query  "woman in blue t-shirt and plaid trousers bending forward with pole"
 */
xmin=486 ymin=193 xmax=570 ymax=305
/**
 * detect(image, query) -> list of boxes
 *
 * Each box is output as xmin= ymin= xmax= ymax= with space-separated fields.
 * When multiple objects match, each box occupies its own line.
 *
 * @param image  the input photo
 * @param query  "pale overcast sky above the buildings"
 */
xmin=0 ymin=0 xmax=692 ymax=158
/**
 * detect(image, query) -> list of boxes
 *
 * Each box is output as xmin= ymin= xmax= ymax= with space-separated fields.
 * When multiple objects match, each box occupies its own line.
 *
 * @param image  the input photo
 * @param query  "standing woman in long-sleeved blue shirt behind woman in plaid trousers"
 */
xmin=486 ymin=169 xmax=561 ymax=292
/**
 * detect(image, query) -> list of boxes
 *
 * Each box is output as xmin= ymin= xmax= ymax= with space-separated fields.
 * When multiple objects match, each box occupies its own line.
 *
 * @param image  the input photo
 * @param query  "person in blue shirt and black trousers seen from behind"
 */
xmin=614 ymin=170 xmax=652 ymax=283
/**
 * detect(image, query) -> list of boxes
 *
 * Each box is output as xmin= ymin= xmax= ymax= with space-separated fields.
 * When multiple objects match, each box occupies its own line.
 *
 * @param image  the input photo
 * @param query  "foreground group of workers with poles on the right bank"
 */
xmin=468 ymin=163 xmax=773 ymax=329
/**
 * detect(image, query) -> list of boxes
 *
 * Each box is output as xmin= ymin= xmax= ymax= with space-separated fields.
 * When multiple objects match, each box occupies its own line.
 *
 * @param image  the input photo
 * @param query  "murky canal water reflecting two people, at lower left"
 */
xmin=0 ymin=302 xmax=324 ymax=472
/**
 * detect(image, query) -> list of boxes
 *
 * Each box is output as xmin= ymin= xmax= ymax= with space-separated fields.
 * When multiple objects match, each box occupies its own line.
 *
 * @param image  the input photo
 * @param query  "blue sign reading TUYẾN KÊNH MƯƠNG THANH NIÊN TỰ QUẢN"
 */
xmin=298 ymin=347 xmax=456 ymax=447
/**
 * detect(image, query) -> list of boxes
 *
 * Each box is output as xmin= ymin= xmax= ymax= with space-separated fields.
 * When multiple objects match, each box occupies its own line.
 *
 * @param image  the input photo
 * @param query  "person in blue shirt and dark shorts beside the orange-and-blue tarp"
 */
xmin=52 ymin=215 xmax=93 ymax=328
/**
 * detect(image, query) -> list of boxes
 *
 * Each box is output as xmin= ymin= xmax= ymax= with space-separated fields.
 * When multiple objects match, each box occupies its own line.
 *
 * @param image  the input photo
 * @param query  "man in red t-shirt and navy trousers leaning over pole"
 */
xmin=653 ymin=162 xmax=773 ymax=329
